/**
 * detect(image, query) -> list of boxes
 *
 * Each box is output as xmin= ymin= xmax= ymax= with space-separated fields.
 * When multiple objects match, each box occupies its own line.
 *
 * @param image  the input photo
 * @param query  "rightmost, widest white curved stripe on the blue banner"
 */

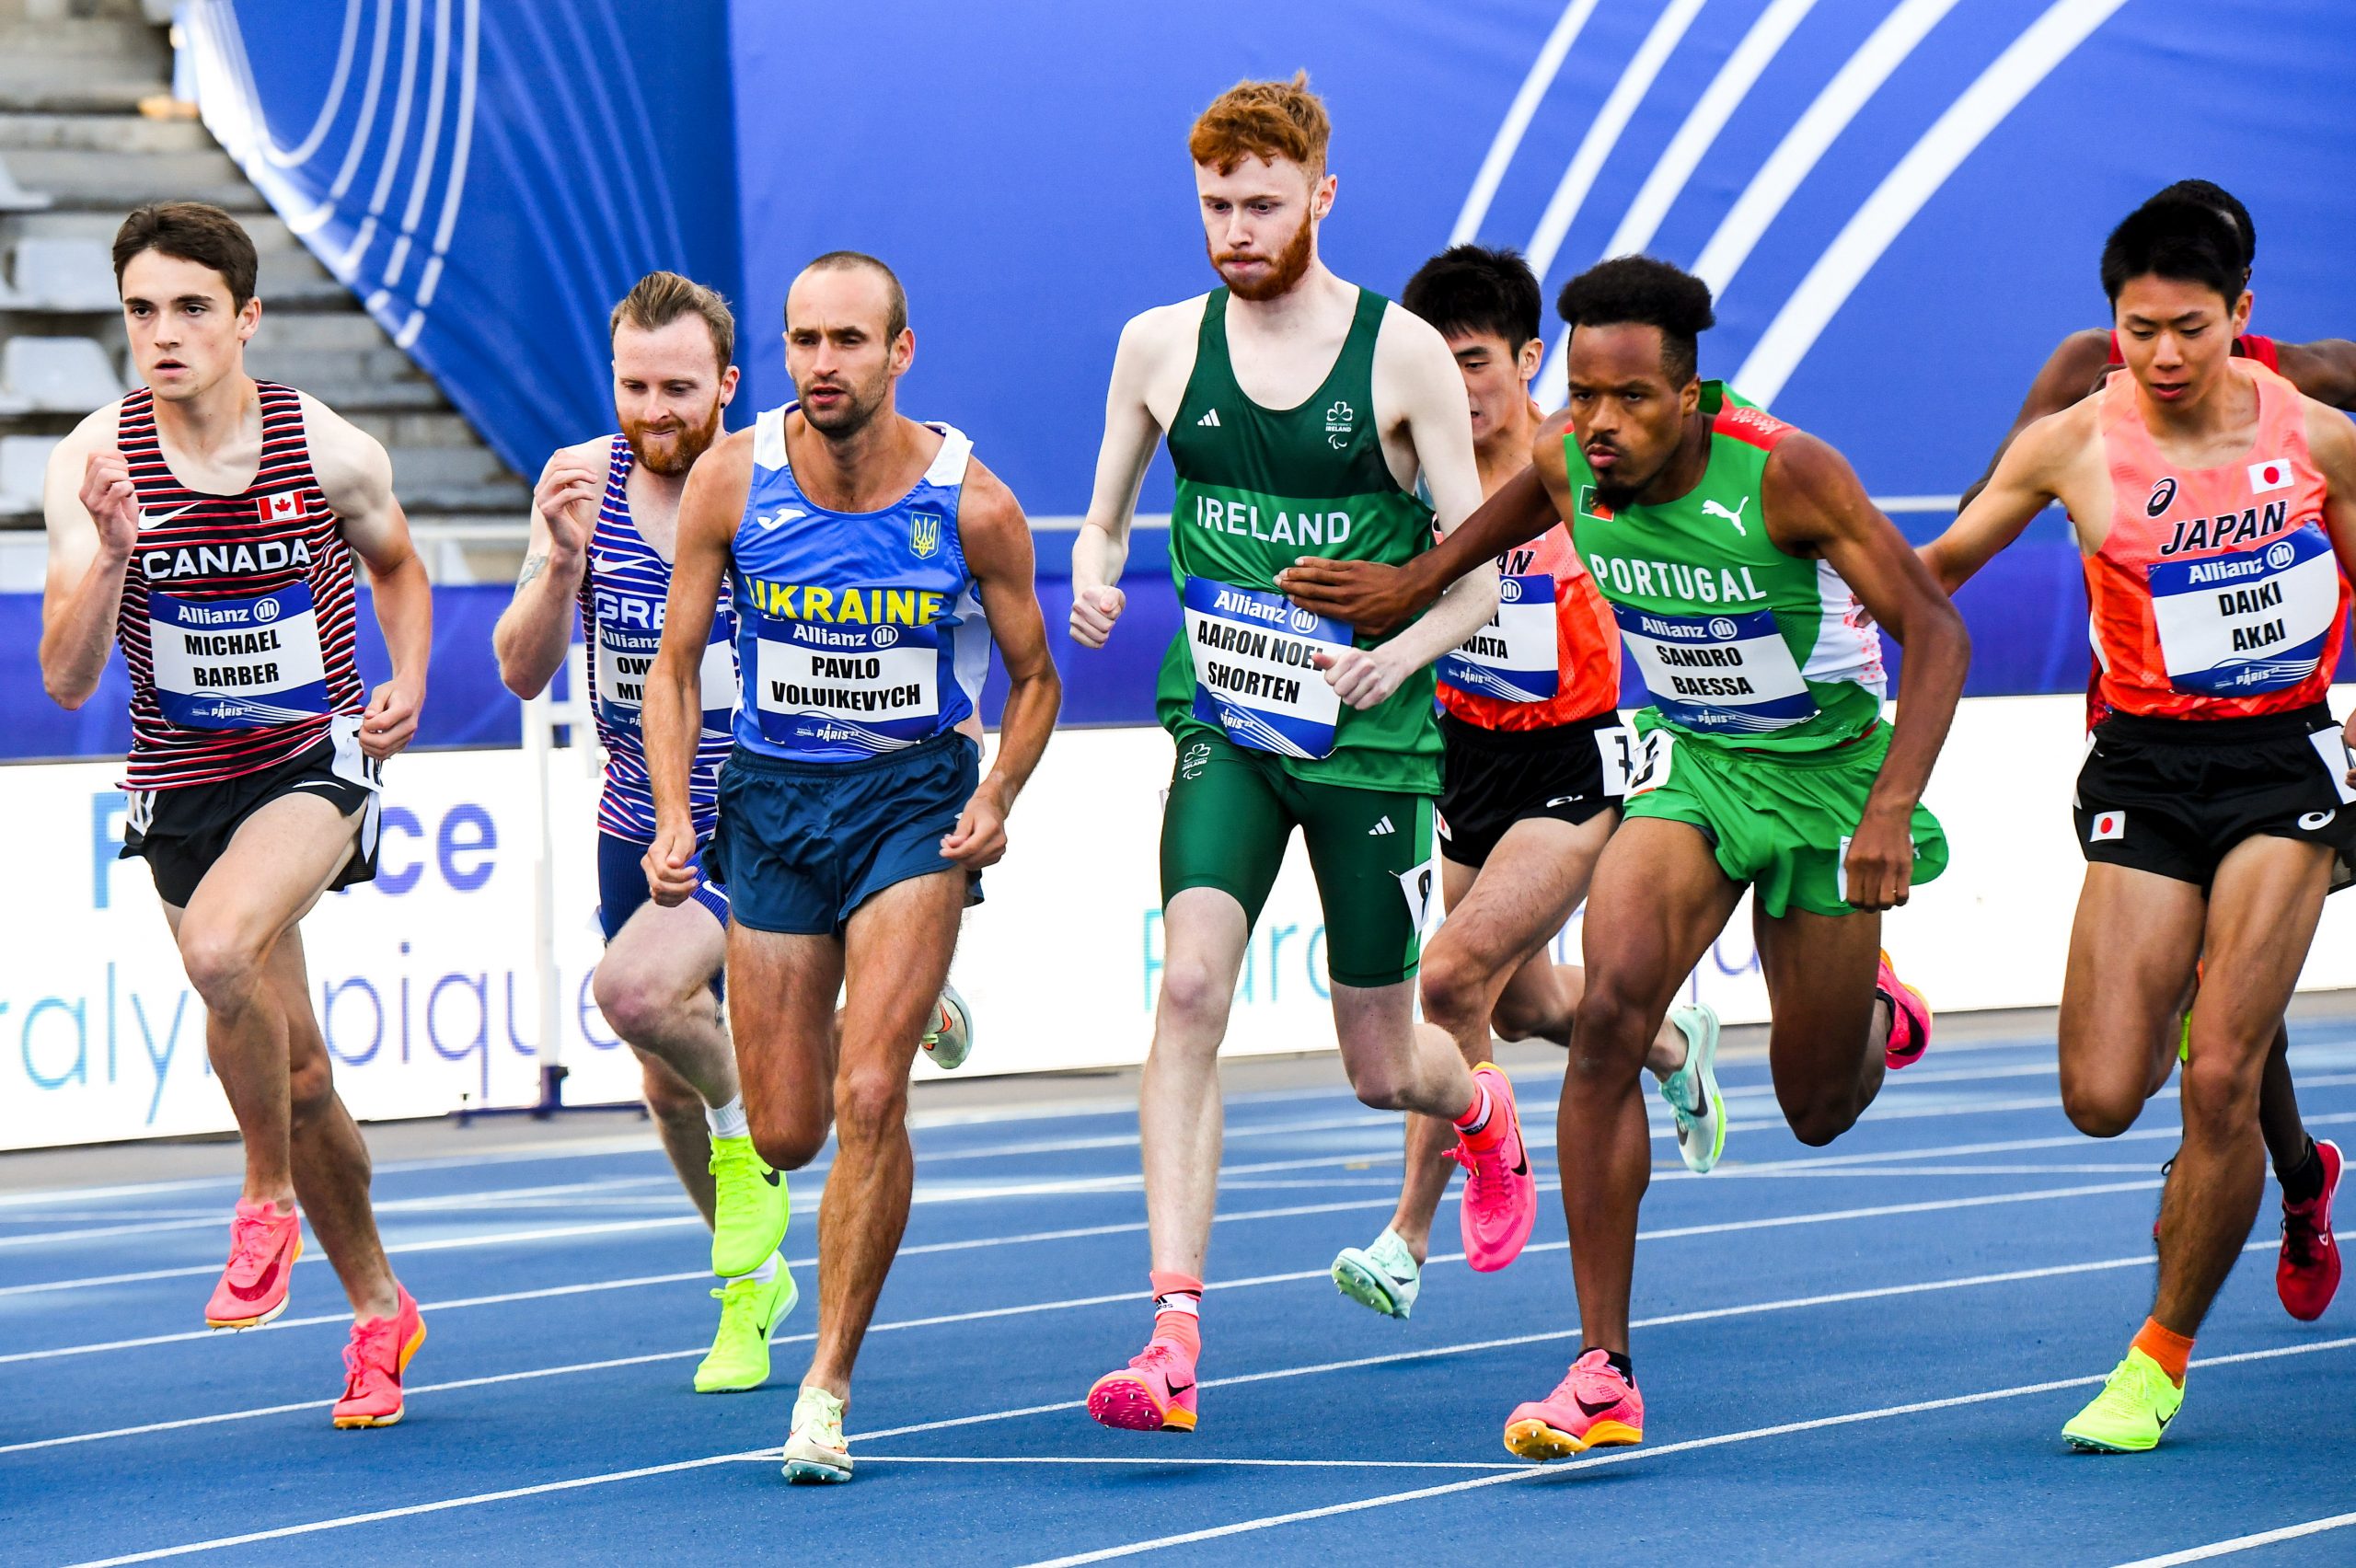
xmin=1734 ymin=0 xmax=2128 ymax=405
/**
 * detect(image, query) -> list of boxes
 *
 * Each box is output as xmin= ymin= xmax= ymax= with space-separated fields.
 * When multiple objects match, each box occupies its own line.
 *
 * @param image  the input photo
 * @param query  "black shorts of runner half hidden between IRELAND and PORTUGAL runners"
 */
xmin=1439 ymin=711 xmax=1631 ymax=867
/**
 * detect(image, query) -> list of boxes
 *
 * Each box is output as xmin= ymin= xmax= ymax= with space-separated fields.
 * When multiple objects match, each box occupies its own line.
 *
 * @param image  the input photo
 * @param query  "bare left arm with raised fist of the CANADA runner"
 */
xmin=40 ymin=403 xmax=139 ymax=709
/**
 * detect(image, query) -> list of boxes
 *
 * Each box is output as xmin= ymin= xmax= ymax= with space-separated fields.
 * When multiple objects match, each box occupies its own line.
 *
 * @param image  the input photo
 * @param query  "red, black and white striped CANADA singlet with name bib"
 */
xmin=115 ymin=381 xmax=365 ymax=789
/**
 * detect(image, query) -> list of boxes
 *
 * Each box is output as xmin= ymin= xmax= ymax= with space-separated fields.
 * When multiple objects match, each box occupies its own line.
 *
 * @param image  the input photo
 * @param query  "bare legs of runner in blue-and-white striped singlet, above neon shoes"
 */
xmin=592 ymin=902 xmax=737 ymax=1224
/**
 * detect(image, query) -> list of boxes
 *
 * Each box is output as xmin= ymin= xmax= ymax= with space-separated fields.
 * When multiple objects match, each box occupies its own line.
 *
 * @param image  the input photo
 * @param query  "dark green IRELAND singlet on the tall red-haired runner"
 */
xmin=1154 ymin=290 xmax=1439 ymax=796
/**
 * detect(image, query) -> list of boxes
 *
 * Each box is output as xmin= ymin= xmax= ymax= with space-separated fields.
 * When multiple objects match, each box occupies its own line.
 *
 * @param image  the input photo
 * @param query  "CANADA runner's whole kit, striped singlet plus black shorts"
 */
xmin=115 ymin=381 xmax=382 ymax=906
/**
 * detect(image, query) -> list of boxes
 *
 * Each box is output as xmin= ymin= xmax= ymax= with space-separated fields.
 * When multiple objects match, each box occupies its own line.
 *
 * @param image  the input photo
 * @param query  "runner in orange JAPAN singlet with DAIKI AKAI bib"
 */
xmin=1923 ymin=198 xmax=2356 ymax=1453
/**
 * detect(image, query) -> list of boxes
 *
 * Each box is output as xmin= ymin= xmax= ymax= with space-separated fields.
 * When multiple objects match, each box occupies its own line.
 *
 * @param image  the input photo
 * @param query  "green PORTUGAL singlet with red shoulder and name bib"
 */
xmin=1562 ymin=381 xmax=1888 ymax=754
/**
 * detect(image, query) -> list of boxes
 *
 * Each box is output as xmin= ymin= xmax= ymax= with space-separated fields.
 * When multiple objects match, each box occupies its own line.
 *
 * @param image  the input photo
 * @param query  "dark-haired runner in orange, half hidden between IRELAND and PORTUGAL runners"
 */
xmin=1334 ymin=245 xmax=1727 ymax=1319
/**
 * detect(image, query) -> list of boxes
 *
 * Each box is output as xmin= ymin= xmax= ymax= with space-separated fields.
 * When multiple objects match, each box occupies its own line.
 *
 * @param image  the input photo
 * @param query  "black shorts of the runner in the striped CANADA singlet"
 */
xmin=118 ymin=734 xmax=384 ymax=909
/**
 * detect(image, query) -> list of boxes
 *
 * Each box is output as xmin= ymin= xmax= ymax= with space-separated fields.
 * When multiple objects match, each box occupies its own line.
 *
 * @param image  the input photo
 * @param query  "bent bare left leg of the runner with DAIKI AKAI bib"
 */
xmin=2059 ymin=861 xmax=2205 ymax=1137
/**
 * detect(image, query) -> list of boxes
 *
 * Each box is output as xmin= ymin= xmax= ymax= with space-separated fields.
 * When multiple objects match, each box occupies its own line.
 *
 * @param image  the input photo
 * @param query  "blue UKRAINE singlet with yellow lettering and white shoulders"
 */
xmin=731 ymin=405 xmax=989 ymax=763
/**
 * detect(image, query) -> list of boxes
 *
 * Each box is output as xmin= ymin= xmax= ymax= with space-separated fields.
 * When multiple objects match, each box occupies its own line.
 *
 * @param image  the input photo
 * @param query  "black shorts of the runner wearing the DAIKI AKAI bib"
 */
xmin=2075 ymin=704 xmax=2356 ymax=890
